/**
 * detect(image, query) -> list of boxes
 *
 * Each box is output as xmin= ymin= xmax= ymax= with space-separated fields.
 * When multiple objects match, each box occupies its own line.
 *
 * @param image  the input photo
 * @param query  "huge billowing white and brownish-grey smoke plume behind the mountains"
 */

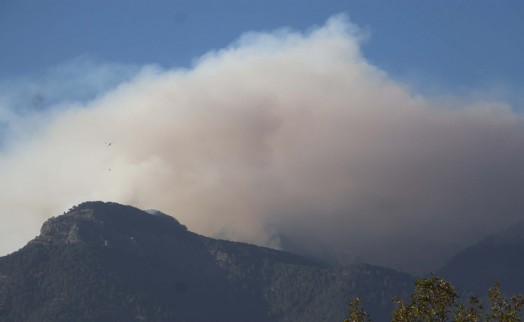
xmin=0 ymin=16 xmax=524 ymax=271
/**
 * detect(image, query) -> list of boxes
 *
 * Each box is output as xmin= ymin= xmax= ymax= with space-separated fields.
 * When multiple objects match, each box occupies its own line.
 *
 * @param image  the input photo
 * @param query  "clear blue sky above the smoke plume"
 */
xmin=0 ymin=0 xmax=524 ymax=100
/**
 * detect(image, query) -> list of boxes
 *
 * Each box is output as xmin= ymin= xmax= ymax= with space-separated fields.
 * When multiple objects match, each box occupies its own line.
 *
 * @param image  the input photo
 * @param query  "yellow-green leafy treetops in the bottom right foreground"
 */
xmin=344 ymin=275 xmax=524 ymax=322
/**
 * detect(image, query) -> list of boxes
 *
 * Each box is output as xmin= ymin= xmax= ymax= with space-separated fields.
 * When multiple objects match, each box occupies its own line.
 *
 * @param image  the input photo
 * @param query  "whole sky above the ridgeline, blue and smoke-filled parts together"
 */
xmin=0 ymin=0 xmax=524 ymax=273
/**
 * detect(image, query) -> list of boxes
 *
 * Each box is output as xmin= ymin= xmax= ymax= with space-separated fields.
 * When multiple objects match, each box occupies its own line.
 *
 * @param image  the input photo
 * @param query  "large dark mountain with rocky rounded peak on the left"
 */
xmin=0 ymin=202 xmax=413 ymax=322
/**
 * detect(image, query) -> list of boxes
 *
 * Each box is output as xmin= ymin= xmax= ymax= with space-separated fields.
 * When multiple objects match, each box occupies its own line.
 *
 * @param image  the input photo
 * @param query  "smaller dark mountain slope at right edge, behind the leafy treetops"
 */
xmin=438 ymin=222 xmax=524 ymax=294
